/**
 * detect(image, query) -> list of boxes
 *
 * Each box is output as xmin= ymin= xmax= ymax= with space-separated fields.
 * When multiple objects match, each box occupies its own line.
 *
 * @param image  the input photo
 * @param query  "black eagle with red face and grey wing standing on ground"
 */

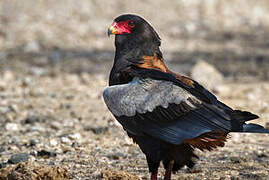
xmin=103 ymin=14 xmax=269 ymax=180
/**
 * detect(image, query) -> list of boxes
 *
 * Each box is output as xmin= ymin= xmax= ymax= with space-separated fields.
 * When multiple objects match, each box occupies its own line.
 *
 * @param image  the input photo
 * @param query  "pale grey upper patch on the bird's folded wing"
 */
xmin=103 ymin=78 xmax=199 ymax=117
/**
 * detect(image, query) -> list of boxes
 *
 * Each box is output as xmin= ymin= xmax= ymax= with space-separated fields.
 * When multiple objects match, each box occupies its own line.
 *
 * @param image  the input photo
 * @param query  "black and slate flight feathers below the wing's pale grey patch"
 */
xmin=116 ymin=101 xmax=234 ymax=144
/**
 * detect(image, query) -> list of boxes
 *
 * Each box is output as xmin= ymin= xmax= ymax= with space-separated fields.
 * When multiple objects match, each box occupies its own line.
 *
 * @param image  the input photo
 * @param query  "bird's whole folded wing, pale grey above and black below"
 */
xmin=104 ymin=78 xmax=243 ymax=144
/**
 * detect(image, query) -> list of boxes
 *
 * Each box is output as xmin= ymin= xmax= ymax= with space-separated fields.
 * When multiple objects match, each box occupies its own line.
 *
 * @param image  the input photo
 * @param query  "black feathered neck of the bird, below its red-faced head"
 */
xmin=109 ymin=35 xmax=162 ymax=85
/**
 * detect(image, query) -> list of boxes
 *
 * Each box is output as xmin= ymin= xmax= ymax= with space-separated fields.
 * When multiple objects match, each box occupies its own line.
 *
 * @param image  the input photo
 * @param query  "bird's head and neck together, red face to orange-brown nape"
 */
xmin=107 ymin=14 xmax=165 ymax=85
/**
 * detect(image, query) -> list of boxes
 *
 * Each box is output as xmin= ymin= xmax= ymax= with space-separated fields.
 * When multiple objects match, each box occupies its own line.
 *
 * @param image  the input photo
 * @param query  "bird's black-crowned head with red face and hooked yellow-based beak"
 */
xmin=107 ymin=14 xmax=161 ymax=46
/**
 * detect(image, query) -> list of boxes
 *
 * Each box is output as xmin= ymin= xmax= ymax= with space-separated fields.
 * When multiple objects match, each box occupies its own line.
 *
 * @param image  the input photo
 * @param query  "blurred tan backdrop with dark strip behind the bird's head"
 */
xmin=0 ymin=0 xmax=269 ymax=79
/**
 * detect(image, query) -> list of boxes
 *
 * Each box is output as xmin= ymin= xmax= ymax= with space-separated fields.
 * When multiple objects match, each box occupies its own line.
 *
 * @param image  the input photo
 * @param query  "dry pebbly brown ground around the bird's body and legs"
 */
xmin=0 ymin=61 xmax=269 ymax=179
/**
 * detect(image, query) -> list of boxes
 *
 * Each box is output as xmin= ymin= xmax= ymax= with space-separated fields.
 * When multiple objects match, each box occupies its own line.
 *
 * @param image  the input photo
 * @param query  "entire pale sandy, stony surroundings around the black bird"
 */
xmin=0 ymin=0 xmax=269 ymax=179
